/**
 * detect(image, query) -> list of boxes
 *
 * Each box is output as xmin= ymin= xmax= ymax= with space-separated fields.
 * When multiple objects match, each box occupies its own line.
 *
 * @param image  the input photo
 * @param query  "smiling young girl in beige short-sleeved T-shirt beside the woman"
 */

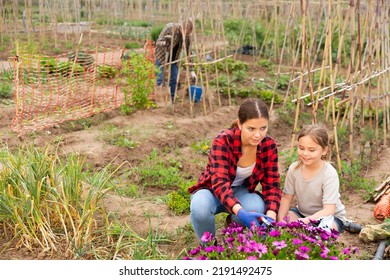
xmin=278 ymin=125 xmax=346 ymax=232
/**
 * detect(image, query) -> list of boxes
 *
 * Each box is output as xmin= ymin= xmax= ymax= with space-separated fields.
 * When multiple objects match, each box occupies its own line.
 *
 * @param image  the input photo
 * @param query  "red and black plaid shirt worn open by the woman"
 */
xmin=188 ymin=127 xmax=282 ymax=213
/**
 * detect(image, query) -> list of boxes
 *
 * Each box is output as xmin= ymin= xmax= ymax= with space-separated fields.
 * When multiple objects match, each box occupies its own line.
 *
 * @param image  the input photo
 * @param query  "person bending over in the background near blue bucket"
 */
xmin=155 ymin=20 xmax=196 ymax=103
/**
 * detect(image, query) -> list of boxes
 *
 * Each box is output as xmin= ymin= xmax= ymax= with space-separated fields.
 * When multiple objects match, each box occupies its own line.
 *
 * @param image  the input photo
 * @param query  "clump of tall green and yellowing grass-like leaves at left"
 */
xmin=0 ymin=146 xmax=115 ymax=252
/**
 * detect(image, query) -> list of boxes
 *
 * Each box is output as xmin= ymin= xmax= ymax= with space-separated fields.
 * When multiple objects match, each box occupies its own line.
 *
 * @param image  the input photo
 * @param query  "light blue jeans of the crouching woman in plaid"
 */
xmin=190 ymin=186 xmax=265 ymax=243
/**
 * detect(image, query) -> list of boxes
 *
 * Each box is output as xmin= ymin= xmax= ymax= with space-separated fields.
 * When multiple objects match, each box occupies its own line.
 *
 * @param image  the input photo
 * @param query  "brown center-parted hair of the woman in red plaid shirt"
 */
xmin=231 ymin=98 xmax=269 ymax=127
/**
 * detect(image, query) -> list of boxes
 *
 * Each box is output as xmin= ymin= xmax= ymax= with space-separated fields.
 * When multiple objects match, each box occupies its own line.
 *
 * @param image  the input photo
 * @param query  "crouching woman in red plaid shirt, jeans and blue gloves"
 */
xmin=189 ymin=99 xmax=282 ymax=243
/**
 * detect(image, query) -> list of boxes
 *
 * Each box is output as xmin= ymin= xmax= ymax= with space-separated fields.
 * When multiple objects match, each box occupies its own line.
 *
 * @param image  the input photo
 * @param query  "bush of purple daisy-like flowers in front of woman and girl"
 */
xmin=184 ymin=221 xmax=359 ymax=260
